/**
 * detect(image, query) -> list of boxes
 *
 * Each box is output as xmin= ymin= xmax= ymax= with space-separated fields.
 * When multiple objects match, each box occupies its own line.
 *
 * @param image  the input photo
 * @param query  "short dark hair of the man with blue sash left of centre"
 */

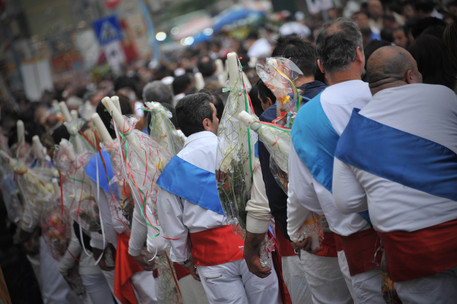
xmin=176 ymin=93 xmax=213 ymax=136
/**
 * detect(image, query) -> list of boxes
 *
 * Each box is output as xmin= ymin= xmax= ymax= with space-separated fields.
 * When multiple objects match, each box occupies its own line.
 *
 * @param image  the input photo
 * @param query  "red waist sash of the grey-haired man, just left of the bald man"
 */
xmin=335 ymin=228 xmax=382 ymax=276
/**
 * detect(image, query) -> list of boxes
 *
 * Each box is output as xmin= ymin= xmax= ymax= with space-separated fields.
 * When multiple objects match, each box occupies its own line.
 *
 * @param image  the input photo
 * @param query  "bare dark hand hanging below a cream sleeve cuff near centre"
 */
xmin=243 ymin=231 xmax=271 ymax=279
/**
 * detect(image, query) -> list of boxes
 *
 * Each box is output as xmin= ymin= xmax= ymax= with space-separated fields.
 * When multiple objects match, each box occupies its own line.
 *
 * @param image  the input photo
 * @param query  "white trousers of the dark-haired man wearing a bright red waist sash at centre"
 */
xmin=197 ymin=259 xmax=282 ymax=304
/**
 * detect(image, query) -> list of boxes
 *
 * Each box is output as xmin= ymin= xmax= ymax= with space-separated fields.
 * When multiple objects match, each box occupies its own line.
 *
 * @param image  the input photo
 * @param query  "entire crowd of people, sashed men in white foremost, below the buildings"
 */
xmin=0 ymin=0 xmax=457 ymax=304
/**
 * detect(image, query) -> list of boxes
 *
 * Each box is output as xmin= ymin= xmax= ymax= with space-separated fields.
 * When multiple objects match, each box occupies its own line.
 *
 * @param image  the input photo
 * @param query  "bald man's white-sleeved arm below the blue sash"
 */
xmin=332 ymin=158 xmax=368 ymax=214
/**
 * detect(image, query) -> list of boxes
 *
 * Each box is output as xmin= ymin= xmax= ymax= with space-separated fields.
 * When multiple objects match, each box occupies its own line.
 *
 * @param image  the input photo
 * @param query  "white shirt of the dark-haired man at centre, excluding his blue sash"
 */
xmin=157 ymin=131 xmax=227 ymax=262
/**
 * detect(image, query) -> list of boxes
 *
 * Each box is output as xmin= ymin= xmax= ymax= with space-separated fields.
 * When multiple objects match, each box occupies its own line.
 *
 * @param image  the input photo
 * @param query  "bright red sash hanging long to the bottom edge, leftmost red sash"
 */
xmin=114 ymin=233 xmax=143 ymax=304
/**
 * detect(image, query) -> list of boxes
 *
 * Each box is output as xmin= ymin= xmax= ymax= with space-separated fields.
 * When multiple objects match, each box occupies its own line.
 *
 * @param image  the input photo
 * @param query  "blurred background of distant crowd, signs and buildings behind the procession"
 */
xmin=0 ymin=0 xmax=457 ymax=148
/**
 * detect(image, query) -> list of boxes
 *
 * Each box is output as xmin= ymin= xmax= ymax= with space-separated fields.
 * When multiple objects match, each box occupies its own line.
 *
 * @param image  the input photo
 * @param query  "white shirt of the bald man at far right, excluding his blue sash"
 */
xmin=333 ymin=84 xmax=457 ymax=232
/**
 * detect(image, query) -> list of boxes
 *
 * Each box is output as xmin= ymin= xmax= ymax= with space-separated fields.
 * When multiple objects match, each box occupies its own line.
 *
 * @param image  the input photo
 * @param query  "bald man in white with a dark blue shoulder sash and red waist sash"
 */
xmin=333 ymin=46 xmax=457 ymax=303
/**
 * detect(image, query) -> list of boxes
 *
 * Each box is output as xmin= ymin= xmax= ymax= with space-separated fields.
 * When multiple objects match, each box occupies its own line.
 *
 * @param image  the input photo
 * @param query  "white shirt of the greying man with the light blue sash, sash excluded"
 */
xmin=287 ymin=80 xmax=371 ymax=241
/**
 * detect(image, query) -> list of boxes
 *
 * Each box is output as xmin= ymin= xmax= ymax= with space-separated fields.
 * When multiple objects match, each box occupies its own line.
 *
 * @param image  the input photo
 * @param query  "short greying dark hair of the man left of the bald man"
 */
xmin=316 ymin=18 xmax=363 ymax=73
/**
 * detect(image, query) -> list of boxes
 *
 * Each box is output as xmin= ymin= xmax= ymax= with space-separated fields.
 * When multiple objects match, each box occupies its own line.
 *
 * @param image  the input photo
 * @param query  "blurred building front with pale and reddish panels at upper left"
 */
xmin=0 ymin=0 xmax=157 ymax=100
